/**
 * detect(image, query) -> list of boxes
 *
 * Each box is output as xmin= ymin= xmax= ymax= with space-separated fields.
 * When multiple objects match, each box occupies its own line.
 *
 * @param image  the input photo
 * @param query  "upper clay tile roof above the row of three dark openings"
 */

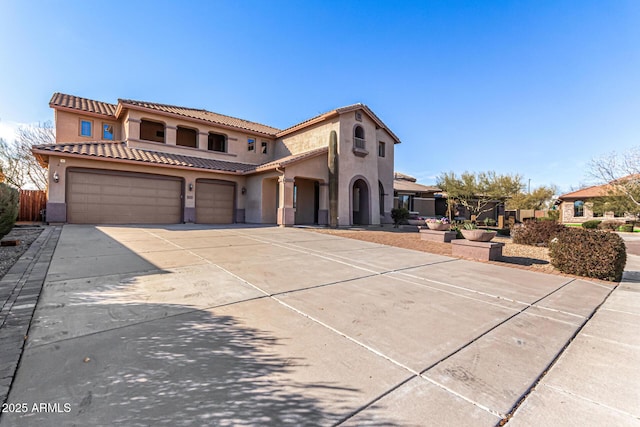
xmin=118 ymin=99 xmax=280 ymax=137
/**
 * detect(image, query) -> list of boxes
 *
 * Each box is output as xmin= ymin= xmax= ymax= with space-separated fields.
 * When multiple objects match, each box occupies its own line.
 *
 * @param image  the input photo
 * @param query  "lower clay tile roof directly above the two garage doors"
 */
xmin=32 ymin=142 xmax=256 ymax=173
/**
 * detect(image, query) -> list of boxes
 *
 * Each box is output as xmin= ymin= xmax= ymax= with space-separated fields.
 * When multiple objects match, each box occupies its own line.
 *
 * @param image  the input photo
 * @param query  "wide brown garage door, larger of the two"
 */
xmin=67 ymin=169 xmax=183 ymax=224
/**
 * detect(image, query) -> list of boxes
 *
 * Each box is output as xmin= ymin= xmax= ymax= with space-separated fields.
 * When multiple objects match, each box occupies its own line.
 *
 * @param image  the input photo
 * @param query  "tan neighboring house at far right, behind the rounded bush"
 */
xmin=556 ymin=184 xmax=635 ymax=224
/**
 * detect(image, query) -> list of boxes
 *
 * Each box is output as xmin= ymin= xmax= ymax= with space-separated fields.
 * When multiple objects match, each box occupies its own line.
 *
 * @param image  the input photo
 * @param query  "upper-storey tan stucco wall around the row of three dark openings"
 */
xmin=126 ymin=110 xmax=275 ymax=164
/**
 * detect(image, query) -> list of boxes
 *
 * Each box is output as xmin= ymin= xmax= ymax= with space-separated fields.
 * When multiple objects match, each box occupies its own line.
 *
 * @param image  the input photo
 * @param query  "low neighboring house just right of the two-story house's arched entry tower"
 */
xmin=393 ymin=172 xmax=447 ymax=217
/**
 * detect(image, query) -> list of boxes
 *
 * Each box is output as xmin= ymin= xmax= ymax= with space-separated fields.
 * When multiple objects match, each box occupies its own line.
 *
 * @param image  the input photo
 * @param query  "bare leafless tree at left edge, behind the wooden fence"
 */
xmin=0 ymin=122 xmax=56 ymax=190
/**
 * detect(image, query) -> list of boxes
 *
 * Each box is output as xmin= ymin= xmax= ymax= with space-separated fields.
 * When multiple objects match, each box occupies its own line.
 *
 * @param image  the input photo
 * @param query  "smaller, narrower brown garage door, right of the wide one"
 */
xmin=196 ymin=180 xmax=236 ymax=224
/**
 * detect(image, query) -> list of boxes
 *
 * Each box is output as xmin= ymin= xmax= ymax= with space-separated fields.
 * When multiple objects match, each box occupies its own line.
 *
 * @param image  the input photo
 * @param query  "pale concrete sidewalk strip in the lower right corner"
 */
xmin=509 ymin=251 xmax=640 ymax=426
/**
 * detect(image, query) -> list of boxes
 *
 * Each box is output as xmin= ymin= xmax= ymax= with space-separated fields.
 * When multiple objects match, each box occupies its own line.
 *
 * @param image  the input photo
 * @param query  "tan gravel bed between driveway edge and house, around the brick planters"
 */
xmin=310 ymin=227 xmax=557 ymax=273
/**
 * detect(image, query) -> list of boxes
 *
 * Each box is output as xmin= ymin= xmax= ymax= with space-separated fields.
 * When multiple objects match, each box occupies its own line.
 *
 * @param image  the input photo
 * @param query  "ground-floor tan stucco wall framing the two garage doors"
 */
xmin=49 ymin=156 xmax=246 ymax=209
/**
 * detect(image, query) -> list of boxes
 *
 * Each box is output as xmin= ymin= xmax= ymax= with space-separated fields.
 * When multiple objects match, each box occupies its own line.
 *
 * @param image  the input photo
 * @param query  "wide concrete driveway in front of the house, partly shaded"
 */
xmin=0 ymin=225 xmax=612 ymax=426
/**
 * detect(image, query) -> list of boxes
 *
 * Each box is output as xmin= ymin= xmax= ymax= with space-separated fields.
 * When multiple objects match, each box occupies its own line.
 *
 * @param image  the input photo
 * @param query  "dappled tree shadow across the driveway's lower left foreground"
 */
xmin=5 ymin=305 xmax=398 ymax=426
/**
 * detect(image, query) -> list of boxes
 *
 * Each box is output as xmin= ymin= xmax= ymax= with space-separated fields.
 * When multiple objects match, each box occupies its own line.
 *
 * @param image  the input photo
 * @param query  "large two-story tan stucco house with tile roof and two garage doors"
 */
xmin=33 ymin=93 xmax=400 ymax=226
